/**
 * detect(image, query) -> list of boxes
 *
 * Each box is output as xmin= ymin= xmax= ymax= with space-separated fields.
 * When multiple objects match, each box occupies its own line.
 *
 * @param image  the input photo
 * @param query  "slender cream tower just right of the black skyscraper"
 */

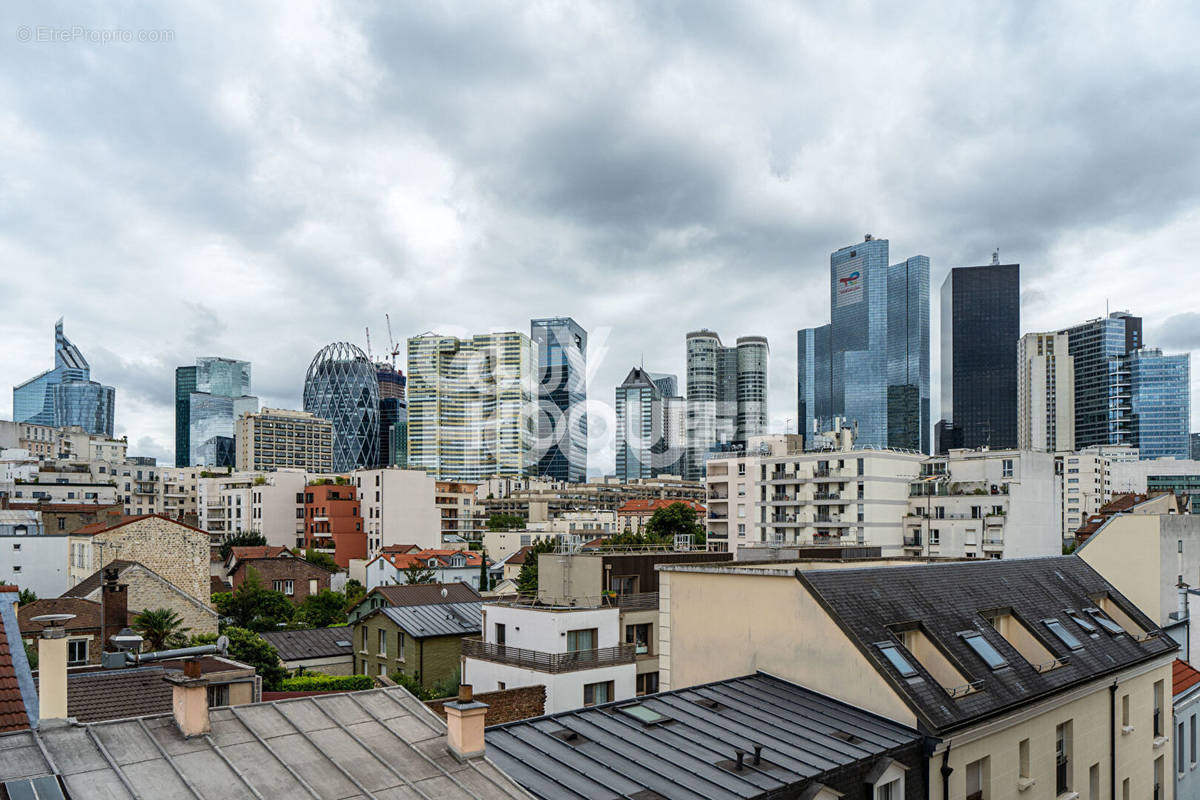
xmin=1016 ymin=333 xmax=1075 ymax=452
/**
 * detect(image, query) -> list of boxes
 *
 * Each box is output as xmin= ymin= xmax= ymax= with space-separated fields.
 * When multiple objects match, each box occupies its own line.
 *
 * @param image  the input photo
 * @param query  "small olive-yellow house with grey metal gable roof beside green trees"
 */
xmin=353 ymin=600 xmax=484 ymax=688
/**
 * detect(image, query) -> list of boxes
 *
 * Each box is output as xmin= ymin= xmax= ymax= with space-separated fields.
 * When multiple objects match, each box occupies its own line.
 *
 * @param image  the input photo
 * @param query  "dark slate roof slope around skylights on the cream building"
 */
xmin=796 ymin=555 xmax=1178 ymax=733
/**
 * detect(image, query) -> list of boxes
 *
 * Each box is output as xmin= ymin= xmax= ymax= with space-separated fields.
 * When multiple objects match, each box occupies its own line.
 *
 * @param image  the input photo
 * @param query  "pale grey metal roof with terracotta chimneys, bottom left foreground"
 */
xmin=0 ymin=687 xmax=526 ymax=800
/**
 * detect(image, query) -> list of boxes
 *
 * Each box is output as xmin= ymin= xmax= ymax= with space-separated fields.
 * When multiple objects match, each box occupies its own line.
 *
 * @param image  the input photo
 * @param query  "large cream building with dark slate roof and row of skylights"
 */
xmin=662 ymin=557 xmax=1177 ymax=800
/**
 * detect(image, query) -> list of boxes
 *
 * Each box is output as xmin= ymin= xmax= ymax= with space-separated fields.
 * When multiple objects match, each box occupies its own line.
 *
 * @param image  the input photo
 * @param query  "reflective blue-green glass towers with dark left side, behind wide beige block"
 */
xmin=175 ymin=356 xmax=258 ymax=467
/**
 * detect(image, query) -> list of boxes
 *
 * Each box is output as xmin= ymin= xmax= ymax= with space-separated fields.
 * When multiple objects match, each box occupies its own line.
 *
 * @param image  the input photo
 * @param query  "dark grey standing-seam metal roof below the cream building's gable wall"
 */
xmin=486 ymin=673 xmax=922 ymax=800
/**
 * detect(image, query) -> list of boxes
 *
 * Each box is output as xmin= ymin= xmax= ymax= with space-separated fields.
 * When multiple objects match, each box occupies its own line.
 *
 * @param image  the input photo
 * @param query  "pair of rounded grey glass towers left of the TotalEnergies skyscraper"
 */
xmin=684 ymin=330 xmax=770 ymax=480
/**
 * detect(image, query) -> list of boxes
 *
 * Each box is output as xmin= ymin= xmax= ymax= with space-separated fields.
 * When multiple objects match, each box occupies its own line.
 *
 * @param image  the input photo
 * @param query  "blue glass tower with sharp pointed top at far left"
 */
xmin=12 ymin=319 xmax=116 ymax=438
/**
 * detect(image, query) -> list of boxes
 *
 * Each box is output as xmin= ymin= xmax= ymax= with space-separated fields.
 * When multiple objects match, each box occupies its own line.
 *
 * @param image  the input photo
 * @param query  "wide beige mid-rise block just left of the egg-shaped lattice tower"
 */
xmin=235 ymin=408 xmax=334 ymax=473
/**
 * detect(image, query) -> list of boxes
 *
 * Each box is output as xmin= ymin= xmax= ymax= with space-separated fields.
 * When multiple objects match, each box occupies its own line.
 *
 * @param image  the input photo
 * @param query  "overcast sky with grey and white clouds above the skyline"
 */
xmin=0 ymin=0 xmax=1200 ymax=473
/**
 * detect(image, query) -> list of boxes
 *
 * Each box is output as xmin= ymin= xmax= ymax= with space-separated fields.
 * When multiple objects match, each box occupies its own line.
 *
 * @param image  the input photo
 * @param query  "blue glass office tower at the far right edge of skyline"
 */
xmin=1128 ymin=348 xmax=1192 ymax=458
